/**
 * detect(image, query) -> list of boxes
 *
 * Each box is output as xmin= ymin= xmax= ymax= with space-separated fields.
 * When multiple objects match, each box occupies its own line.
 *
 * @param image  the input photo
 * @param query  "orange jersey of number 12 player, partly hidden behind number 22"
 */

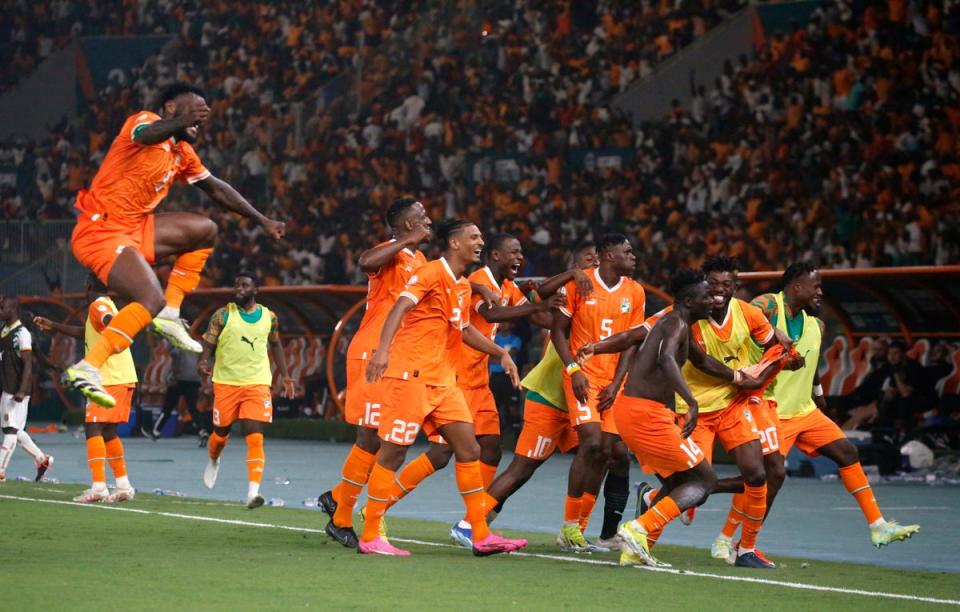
xmin=347 ymin=240 xmax=427 ymax=359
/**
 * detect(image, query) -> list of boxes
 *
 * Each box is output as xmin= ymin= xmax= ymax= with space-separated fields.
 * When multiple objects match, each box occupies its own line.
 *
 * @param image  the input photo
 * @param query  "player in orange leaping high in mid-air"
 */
xmin=64 ymin=83 xmax=285 ymax=407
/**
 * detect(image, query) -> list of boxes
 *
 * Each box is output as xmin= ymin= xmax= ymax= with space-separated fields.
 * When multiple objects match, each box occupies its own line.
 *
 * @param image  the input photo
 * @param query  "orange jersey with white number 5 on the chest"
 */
xmin=560 ymin=268 xmax=646 ymax=384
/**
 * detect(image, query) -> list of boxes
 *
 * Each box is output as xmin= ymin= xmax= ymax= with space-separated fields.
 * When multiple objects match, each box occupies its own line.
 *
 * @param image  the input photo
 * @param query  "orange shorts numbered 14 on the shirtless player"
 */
xmin=609 ymin=395 xmax=706 ymax=478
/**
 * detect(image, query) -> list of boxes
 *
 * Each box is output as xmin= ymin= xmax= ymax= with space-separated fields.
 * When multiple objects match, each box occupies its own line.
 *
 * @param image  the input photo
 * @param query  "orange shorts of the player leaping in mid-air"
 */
xmin=70 ymin=214 xmax=155 ymax=285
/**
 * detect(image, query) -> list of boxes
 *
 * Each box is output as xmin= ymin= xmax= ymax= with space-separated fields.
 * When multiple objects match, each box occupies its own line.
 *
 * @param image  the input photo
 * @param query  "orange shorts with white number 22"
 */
xmin=377 ymin=378 xmax=473 ymax=446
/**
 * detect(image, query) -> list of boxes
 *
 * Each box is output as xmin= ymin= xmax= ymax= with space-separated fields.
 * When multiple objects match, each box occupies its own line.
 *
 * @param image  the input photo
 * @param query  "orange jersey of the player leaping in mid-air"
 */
xmin=76 ymin=111 xmax=210 ymax=226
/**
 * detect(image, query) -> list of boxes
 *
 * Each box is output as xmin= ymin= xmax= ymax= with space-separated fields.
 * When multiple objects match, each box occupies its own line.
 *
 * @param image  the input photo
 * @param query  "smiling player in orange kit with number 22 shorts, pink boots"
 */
xmin=358 ymin=220 xmax=526 ymax=556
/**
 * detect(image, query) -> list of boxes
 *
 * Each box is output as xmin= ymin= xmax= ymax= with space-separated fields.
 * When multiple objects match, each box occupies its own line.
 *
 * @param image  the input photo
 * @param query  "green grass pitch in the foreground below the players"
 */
xmin=0 ymin=482 xmax=960 ymax=610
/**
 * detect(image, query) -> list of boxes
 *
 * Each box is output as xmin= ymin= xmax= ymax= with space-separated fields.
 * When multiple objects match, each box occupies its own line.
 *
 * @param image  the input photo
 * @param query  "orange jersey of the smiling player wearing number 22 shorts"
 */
xmin=383 ymin=257 xmax=470 ymax=387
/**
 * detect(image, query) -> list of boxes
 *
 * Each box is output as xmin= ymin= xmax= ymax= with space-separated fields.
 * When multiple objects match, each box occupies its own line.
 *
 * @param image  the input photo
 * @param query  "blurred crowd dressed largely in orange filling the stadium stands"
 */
xmin=0 ymin=0 xmax=960 ymax=292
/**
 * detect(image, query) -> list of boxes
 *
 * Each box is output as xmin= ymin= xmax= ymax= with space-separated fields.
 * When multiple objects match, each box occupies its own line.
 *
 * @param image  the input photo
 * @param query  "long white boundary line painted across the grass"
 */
xmin=0 ymin=495 xmax=960 ymax=606
